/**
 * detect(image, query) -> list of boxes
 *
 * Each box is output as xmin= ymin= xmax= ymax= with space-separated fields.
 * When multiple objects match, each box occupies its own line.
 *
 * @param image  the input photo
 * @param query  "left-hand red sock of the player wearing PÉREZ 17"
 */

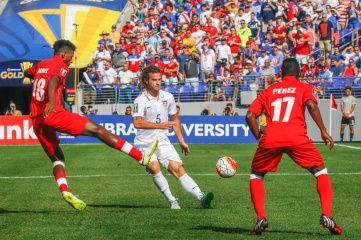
xmin=249 ymin=178 xmax=266 ymax=221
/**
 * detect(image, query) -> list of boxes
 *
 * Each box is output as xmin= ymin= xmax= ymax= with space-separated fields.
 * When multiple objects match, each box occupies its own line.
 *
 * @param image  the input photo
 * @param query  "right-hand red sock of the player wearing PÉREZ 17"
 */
xmin=316 ymin=174 xmax=333 ymax=218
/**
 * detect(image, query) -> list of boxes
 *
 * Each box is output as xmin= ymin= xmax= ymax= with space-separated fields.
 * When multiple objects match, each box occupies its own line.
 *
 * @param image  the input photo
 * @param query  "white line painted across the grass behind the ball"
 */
xmin=0 ymin=172 xmax=361 ymax=179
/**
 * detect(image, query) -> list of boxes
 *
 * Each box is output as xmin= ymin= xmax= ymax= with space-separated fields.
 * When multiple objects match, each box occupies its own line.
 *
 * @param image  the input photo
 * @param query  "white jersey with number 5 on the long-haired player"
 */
xmin=133 ymin=90 xmax=177 ymax=145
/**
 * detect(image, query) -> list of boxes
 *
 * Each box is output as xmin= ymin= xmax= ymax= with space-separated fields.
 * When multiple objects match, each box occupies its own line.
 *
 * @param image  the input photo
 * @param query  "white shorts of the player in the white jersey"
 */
xmin=134 ymin=137 xmax=182 ymax=169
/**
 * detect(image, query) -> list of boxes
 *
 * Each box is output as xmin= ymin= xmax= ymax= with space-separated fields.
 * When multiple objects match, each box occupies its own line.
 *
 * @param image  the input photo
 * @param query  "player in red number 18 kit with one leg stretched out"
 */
xmin=24 ymin=40 xmax=158 ymax=211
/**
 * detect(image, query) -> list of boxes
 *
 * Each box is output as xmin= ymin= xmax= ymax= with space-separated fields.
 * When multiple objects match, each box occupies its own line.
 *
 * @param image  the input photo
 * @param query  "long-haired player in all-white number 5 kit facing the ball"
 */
xmin=133 ymin=65 xmax=214 ymax=209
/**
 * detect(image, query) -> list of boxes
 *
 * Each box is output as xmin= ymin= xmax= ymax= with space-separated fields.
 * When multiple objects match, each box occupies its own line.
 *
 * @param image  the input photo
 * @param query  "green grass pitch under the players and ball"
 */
xmin=0 ymin=143 xmax=361 ymax=240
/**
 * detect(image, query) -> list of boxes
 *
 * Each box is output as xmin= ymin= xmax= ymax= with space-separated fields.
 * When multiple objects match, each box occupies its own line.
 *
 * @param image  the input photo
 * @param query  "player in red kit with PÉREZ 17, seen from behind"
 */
xmin=246 ymin=58 xmax=342 ymax=235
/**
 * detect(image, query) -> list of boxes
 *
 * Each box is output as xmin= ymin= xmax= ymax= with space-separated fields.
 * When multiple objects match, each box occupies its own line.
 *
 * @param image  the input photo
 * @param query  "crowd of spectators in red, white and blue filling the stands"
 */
xmin=81 ymin=0 xmax=361 ymax=104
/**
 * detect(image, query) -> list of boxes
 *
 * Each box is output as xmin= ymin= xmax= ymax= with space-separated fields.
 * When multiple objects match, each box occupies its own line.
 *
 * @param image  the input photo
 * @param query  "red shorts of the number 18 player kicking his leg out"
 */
xmin=32 ymin=111 xmax=88 ymax=156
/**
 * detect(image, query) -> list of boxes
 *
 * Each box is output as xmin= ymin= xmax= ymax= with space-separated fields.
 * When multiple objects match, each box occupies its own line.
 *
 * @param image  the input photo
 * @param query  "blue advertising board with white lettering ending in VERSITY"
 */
xmin=58 ymin=115 xmax=257 ymax=144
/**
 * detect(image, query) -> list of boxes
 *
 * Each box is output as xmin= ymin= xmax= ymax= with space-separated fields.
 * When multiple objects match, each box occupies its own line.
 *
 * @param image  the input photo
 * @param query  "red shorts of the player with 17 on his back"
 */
xmin=252 ymin=142 xmax=323 ymax=173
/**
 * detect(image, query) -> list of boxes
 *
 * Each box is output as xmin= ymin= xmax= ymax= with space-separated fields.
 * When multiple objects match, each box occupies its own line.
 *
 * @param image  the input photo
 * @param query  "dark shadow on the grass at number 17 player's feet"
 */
xmin=191 ymin=226 xmax=327 ymax=236
